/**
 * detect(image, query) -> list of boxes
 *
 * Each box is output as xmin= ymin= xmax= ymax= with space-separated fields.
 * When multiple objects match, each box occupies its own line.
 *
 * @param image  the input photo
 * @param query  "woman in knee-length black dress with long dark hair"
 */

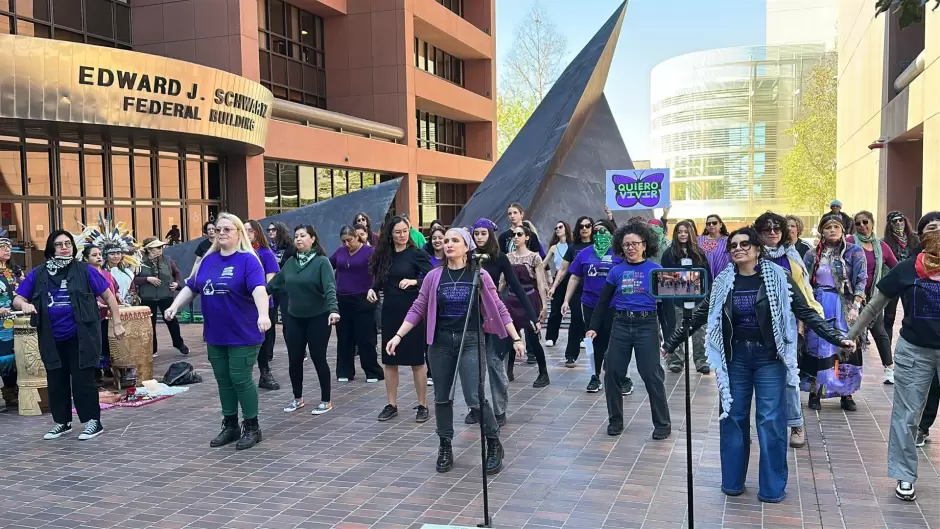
xmin=366 ymin=216 xmax=431 ymax=422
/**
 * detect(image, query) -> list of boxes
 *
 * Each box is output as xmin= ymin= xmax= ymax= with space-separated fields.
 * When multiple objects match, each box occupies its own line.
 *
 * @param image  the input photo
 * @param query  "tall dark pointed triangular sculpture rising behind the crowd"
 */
xmin=454 ymin=2 xmax=648 ymax=229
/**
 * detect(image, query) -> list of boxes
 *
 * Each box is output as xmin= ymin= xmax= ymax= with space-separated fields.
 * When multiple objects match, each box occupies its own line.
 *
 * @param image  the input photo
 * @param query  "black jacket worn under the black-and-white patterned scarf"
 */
xmin=663 ymin=277 xmax=844 ymax=362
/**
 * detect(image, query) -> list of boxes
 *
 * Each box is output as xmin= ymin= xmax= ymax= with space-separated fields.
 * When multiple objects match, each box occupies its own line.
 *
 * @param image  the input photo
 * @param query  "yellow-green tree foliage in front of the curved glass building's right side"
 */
xmin=780 ymin=53 xmax=838 ymax=212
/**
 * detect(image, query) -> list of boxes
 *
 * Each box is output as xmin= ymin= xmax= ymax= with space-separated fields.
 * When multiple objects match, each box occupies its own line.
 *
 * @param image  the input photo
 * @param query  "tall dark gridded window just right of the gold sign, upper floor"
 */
xmin=258 ymin=0 xmax=326 ymax=108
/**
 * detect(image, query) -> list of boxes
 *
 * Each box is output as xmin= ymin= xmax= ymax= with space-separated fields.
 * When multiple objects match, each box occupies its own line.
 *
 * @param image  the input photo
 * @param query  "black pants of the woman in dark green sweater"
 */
xmin=284 ymin=312 xmax=331 ymax=402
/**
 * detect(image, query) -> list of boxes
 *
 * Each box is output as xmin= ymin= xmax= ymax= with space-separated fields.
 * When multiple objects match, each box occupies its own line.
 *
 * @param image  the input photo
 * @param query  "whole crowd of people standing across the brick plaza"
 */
xmin=0 ymin=201 xmax=940 ymax=502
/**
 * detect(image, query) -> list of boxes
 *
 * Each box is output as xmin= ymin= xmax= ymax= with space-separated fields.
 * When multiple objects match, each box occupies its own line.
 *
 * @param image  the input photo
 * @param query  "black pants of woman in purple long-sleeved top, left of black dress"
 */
xmin=336 ymin=294 xmax=385 ymax=380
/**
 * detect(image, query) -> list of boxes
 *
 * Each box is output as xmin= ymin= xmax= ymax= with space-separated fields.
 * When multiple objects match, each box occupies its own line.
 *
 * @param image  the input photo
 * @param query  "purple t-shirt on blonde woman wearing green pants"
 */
xmin=186 ymin=252 xmax=266 ymax=347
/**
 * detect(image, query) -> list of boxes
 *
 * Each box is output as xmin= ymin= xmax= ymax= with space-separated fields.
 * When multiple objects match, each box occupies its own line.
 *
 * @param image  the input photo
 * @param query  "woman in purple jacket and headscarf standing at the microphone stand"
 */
xmin=386 ymin=228 xmax=525 ymax=474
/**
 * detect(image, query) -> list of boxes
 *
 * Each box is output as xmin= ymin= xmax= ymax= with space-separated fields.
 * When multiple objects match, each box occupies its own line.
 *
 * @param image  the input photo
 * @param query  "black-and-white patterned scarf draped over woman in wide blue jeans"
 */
xmin=705 ymin=259 xmax=799 ymax=419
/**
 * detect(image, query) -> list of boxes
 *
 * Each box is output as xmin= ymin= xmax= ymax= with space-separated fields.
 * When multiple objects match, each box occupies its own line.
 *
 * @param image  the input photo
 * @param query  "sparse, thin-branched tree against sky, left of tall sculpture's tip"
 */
xmin=496 ymin=0 xmax=568 ymax=156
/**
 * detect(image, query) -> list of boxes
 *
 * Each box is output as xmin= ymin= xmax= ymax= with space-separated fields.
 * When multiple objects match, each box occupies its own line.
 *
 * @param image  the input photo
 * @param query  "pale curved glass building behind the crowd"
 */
xmin=650 ymin=44 xmax=826 ymax=224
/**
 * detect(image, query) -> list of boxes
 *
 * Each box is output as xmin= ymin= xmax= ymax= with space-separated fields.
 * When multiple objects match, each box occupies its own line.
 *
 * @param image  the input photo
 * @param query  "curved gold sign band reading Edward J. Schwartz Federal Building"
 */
xmin=0 ymin=35 xmax=274 ymax=154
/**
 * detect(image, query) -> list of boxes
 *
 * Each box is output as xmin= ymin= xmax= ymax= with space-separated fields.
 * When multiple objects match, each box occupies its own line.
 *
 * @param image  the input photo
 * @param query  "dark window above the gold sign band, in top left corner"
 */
xmin=0 ymin=0 xmax=131 ymax=50
